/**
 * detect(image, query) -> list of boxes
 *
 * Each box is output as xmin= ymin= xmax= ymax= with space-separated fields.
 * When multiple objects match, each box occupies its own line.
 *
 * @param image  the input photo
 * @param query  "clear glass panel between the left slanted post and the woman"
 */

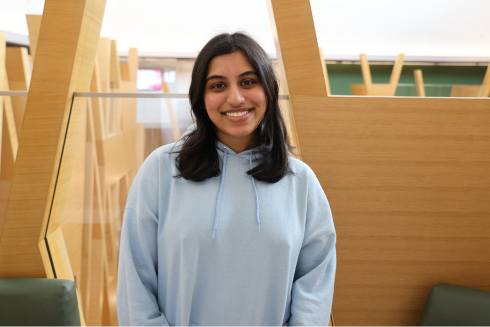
xmin=43 ymin=95 xmax=192 ymax=325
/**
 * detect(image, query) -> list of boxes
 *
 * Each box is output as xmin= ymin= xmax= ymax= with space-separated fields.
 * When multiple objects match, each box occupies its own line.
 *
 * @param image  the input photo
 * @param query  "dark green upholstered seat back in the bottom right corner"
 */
xmin=420 ymin=283 xmax=490 ymax=326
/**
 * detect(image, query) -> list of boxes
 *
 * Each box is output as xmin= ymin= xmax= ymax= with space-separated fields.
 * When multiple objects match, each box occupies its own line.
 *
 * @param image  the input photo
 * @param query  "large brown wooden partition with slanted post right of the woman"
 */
xmin=268 ymin=0 xmax=490 ymax=326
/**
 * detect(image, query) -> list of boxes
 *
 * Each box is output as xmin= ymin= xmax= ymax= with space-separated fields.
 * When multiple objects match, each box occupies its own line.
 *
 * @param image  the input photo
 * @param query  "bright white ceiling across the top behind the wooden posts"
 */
xmin=0 ymin=0 xmax=490 ymax=59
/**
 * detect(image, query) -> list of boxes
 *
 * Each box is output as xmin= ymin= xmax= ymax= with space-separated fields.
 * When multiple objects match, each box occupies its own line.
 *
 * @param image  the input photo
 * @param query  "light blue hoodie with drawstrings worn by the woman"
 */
xmin=117 ymin=126 xmax=336 ymax=326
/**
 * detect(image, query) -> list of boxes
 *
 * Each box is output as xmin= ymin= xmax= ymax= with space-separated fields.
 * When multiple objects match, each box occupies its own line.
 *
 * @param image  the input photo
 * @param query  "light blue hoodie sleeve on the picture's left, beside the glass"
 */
xmin=117 ymin=152 xmax=169 ymax=326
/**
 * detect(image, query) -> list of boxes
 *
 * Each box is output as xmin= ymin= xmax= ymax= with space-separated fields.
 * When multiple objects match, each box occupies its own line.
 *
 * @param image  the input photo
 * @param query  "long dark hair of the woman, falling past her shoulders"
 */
xmin=175 ymin=32 xmax=292 ymax=183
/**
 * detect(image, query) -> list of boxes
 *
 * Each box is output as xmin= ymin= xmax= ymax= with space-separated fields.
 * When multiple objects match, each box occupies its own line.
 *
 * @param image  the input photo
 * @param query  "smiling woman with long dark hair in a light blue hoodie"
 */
xmin=117 ymin=33 xmax=336 ymax=326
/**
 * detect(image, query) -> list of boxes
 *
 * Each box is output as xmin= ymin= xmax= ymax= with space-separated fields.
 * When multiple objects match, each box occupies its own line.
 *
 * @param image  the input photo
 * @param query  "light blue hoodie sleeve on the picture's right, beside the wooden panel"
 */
xmin=288 ymin=170 xmax=337 ymax=326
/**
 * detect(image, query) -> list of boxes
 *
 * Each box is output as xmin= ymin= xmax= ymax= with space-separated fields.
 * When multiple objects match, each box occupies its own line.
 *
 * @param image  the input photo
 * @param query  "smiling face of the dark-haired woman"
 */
xmin=204 ymin=51 xmax=267 ymax=153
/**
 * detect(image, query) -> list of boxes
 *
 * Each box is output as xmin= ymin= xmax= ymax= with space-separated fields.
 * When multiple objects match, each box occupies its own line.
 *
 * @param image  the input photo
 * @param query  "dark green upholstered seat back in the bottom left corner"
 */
xmin=0 ymin=278 xmax=80 ymax=326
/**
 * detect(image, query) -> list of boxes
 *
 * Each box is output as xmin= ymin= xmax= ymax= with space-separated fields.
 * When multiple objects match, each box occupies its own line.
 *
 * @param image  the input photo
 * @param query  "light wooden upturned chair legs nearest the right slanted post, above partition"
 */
xmin=351 ymin=53 xmax=405 ymax=96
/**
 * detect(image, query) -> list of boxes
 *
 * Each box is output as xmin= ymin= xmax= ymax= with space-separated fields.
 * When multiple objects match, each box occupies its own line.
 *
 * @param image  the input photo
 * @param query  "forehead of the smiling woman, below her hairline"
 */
xmin=207 ymin=51 xmax=255 ymax=77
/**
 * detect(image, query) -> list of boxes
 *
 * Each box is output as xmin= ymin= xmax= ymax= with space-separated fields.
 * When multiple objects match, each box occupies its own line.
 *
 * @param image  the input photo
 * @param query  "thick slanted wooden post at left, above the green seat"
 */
xmin=0 ymin=0 xmax=105 ymax=277
